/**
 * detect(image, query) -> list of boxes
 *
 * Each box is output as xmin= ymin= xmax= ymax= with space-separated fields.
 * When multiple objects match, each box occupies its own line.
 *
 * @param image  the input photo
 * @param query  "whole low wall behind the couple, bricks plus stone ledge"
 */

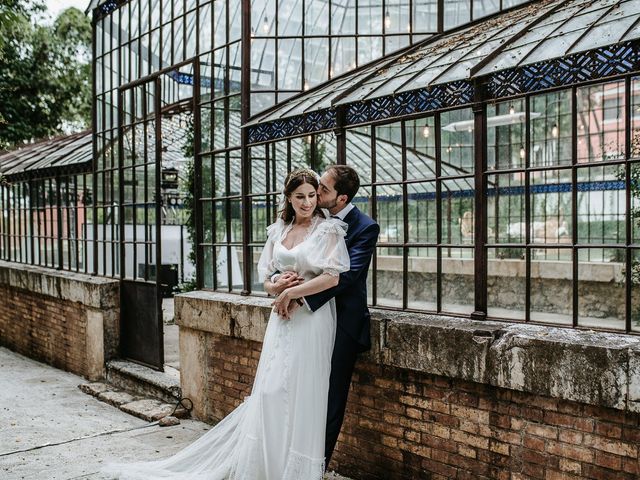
xmin=176 ymin=293 xmax=640 ymax=480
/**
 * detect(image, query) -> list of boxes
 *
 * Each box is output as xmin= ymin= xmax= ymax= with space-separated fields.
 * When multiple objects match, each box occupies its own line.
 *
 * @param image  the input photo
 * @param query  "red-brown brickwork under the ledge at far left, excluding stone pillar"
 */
xmin=0 ymin=285 xmax=88 ymax=376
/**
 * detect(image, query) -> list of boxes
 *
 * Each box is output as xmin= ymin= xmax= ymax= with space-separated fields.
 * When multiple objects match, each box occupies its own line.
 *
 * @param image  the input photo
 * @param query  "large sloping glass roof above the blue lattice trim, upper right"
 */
xmin=248 ymin=0 xmax=640 ymax=125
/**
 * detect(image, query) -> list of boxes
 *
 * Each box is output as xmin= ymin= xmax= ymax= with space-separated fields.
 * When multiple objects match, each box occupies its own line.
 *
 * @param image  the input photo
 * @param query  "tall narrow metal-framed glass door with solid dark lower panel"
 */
xmin=118 ymin=76 xmax=164 ymax=370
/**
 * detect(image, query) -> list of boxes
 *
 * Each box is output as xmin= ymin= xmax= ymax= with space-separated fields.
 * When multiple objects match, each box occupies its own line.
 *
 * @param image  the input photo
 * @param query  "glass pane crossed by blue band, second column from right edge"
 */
xmin=578 ymin=166 xmax=626 ymax=243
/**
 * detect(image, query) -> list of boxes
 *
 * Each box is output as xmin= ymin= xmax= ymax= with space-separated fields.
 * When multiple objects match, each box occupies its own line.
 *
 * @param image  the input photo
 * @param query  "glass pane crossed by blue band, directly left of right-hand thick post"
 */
xmin=440 ymin=179 xmax=474 ymax=244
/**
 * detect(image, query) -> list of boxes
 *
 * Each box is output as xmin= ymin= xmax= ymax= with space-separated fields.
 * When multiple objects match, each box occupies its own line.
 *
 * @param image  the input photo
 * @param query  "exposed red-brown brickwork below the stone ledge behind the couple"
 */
xmin=198 ymin=335 xmax=640 ymax=480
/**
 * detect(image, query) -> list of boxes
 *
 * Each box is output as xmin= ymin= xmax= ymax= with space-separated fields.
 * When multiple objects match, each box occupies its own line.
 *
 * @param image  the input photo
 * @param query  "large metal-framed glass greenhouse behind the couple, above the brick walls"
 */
xmin=0 ymin=0 xmax=640 ymax=370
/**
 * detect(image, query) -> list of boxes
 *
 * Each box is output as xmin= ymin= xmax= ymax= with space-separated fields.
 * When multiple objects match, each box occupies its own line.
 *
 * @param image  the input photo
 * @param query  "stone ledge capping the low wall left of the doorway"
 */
xmin=0 ymin=261 xmax=120 ymax=309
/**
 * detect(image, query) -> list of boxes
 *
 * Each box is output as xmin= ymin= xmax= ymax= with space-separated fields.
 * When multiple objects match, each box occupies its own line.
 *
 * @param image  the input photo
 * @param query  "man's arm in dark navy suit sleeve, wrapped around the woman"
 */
xmin=304 ymin=223 xmax=380 ymax=312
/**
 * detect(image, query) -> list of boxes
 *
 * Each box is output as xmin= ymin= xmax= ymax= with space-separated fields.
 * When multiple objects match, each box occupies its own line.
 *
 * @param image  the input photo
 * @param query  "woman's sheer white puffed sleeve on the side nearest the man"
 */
xmin=308 ymin=218 xmax=350 ymax=277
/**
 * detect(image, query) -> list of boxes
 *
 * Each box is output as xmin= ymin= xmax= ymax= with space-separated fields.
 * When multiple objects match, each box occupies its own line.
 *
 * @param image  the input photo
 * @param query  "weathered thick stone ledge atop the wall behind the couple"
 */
xmin=176 ymin=291 xmax=640 ymax=412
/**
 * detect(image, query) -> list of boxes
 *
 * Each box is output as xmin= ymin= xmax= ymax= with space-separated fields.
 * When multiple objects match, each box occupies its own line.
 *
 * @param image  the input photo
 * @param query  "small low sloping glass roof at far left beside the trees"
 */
xmin=0 ymin=131 xmax=93 ymax=177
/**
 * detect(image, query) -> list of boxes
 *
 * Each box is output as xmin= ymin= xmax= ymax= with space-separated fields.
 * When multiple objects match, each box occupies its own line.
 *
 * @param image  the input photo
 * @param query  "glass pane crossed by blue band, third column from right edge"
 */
xmin=529 ymin=170 xmax=572 ymax=248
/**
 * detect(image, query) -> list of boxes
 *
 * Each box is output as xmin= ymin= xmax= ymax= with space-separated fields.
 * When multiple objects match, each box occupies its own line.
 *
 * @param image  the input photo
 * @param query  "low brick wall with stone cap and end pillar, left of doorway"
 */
xmin=0 ymin=262 xmax=120 ymax=380
